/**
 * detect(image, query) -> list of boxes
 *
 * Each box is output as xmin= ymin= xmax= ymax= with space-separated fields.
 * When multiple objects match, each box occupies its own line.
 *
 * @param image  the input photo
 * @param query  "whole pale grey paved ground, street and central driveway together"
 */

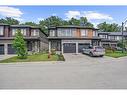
xmin=0 ymin=54 xmax=127 ymax=89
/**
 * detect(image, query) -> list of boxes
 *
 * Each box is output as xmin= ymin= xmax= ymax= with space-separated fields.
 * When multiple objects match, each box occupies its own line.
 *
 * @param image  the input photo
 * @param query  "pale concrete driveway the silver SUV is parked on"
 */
xmin=64 ymin=54 xmax=116 ymax=64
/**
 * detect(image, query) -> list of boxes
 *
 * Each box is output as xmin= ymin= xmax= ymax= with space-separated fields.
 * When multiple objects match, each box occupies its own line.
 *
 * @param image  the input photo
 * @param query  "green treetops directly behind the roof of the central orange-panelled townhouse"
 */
xmin=39 ymin=16 xmax=93 ymax=32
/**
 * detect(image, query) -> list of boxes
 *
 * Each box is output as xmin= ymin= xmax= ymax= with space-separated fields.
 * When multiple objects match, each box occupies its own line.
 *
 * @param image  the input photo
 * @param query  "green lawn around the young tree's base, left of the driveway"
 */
xmin=0 ymin=54 xmax=64 ymax=63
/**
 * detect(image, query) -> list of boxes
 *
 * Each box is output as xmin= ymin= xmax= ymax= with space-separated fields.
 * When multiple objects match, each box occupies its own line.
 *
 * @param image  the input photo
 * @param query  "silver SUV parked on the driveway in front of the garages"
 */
xmin=82 ymin=46 xmax=105 ymax=57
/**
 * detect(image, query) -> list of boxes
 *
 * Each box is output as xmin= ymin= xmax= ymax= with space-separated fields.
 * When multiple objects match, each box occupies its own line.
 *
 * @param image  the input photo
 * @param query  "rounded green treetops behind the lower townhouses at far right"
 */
xmin=97 ymin=22 xmax=121 ymax=32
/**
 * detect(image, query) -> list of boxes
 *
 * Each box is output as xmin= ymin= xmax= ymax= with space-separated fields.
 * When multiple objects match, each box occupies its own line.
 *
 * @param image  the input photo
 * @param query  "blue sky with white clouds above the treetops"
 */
xmin=0 ymin=5 xmax=127 ymax=27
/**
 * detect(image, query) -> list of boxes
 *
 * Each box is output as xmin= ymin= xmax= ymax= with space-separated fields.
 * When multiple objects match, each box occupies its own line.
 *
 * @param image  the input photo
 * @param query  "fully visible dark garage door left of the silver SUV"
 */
xmin=63 ymin=43 xmax=76 ymax=53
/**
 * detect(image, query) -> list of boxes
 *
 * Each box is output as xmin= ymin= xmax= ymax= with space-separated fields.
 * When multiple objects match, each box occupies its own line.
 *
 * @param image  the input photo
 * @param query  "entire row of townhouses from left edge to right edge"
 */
xmin=0 ymin=24 xmax=127 ymax=55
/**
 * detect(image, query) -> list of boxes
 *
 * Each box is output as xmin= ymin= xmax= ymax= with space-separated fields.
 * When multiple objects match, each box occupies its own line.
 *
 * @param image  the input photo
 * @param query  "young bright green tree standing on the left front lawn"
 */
xmin=13 ymin=30 xmax=27 ymax=59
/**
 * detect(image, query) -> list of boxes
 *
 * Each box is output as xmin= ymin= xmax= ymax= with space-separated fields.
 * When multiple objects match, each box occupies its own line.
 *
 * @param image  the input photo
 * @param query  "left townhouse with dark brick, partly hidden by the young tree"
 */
xmin=0 ymin=24 xmax=48 ymax=55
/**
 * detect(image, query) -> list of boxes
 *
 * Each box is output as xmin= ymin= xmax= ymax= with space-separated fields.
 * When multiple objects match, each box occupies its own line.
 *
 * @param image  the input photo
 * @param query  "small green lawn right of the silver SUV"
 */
xmin=105 ymin=51 xmax=127 ymax=58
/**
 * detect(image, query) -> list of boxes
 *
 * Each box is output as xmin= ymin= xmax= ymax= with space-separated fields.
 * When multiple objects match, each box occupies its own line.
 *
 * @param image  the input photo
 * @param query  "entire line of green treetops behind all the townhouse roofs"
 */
xmin=0 ymin=16 xmax=121 ymax=33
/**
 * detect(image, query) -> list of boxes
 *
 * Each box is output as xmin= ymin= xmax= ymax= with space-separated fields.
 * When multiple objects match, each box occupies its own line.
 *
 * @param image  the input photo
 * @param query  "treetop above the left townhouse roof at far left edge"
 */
xmin=0 ymin=17 xmax=19 ymax=25
